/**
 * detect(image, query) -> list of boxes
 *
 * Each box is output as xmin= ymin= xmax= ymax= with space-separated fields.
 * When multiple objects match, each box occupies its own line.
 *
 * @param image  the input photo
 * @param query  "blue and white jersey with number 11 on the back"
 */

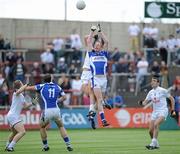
xmin=35 ymin=82 xmax=65 ymax=109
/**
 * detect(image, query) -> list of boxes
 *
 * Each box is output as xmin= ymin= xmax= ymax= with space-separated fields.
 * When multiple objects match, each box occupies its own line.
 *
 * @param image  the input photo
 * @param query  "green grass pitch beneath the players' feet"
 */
xmin=0 ymin=129 xmax=180 ymax=154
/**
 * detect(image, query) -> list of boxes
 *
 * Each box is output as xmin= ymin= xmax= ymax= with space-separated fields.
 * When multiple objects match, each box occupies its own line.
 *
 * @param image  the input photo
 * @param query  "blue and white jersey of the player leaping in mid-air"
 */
xmin=84 ymin=51 xmax=108 ymax=75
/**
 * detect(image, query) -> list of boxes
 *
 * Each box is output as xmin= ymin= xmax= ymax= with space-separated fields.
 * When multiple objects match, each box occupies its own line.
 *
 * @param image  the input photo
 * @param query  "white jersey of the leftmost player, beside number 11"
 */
xmin=8 ymin=92 xmax=25 ymax=116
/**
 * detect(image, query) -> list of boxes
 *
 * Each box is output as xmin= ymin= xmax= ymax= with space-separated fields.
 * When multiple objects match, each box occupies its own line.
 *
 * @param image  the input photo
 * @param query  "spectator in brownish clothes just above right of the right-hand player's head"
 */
xmin=160 ymin=61 xmax=169 ymax=89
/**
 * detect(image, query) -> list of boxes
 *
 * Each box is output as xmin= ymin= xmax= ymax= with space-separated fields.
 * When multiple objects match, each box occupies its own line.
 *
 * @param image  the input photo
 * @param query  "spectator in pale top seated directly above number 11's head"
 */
xmin=40 ymin=45 xmax=54 ymax=73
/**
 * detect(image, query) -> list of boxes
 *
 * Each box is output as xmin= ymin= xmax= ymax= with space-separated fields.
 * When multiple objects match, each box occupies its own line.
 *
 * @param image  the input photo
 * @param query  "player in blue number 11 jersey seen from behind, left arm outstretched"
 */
xmin=25 ymin=74 xmax=73 ymax=151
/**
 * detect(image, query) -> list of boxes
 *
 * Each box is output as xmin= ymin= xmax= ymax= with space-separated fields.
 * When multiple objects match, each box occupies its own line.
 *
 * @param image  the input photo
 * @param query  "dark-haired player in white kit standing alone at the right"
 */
xmin=140 ymin=76 xmax=176 ymax=150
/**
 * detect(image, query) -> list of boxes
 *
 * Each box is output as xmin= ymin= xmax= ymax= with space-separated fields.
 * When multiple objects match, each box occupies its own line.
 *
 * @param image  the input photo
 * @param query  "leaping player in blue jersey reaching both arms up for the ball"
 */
xmin=83 ymin=25 xmax=109 ymax=127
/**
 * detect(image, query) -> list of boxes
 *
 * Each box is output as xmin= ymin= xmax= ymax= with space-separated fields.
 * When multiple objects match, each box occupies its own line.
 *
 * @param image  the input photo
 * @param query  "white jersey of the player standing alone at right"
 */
xmin=146 ymin=87 xmax=170 ymax=111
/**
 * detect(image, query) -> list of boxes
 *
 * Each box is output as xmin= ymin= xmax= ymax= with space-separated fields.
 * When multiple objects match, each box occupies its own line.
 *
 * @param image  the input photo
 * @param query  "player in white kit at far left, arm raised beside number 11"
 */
xmin=5 ymin=80 xmax=32 ymax=152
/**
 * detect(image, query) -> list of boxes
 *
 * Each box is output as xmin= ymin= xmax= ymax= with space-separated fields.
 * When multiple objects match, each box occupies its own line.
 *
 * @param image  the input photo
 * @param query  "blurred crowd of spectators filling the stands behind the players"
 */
xmin=0 ymin=23 xmax=180 ymax=110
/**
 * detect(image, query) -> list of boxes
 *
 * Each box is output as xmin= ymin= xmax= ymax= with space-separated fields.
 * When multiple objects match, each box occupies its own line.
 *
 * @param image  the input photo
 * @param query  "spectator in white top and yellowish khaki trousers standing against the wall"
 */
xmin=128 ymin=22 xmax=140 ymax=52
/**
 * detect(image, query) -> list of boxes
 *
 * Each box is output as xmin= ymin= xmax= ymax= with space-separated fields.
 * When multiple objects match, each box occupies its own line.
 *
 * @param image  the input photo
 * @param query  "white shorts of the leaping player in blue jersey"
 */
xmin=91 ymin=76 xmax=107 ymax=92
